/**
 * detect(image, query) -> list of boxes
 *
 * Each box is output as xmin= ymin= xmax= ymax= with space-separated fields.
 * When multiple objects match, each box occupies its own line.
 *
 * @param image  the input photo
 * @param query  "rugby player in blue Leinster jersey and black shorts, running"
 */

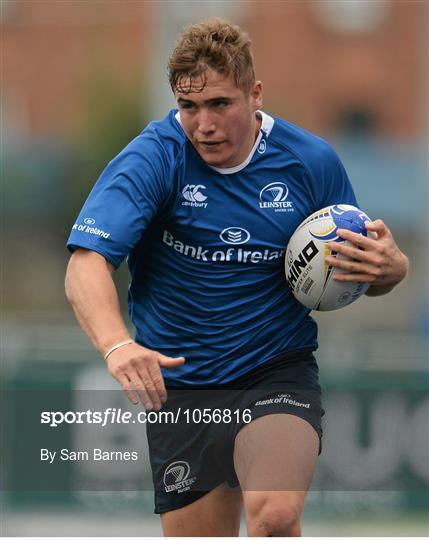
xmin=66 ymin=19 xmax=408 ymax=536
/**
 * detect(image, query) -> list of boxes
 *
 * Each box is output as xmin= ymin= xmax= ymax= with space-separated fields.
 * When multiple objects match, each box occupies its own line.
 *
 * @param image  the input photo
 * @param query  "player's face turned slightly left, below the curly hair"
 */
xmin=175 ymin=70 xmax=262 ymax=167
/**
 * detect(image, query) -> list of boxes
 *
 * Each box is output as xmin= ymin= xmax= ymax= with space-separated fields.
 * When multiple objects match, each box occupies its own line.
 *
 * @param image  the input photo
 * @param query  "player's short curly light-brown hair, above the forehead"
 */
xmin=168 ymin=18 xmax=255 ymax=94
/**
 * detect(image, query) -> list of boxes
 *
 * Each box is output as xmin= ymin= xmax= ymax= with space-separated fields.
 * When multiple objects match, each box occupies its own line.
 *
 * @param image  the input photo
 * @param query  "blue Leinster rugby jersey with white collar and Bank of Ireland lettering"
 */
xmin=68 ymin=111 xmax=357 ymax=386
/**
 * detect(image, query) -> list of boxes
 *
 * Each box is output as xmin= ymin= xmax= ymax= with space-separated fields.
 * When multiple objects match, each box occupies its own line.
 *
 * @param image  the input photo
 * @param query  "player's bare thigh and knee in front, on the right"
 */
xmin=234 ymin=413 xmax=319 ymax=526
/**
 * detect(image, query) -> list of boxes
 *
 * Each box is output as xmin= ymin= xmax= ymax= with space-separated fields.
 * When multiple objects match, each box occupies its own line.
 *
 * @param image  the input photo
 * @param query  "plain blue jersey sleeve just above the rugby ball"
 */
xmin=310 ymin=139 xmax=358 ymax=210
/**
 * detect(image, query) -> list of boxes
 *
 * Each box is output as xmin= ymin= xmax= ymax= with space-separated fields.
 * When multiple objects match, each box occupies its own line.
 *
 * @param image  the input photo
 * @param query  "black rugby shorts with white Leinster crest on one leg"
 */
xmin=147 ymin=350 xmax=324 ymax=514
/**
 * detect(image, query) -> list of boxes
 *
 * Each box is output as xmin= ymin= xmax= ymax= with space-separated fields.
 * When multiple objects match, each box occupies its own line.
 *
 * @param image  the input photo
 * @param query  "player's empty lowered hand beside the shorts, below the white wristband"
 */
xmin=107 ymin=343 xmax=185 ymax=411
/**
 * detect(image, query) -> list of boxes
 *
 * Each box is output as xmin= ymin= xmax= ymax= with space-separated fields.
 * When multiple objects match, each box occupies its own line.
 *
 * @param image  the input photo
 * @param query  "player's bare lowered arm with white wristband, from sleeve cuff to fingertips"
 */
xmin=66 ymin=249 xmax=184 ymax=410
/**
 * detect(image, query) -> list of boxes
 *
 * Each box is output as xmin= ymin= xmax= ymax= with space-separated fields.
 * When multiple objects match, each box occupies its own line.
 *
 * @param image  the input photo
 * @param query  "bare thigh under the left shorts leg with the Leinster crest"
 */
xmin=161 ymin=484 xmax=242 ymax=536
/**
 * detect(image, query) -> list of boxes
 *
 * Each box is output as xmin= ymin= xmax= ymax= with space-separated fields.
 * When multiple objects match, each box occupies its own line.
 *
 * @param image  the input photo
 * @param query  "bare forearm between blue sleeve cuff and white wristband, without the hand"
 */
xmin=65 ymin=252 xmax=130 ymax=354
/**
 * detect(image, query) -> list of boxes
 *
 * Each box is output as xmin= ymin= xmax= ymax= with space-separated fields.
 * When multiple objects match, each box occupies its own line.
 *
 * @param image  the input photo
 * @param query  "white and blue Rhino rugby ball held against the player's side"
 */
xmin=285 ymin=204 xmax=371 ymax=311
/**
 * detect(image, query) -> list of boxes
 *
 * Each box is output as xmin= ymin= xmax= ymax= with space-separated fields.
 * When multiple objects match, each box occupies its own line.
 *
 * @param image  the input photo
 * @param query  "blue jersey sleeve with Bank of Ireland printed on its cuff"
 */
xmin=67 ymin=134 xmax=171 ymax=268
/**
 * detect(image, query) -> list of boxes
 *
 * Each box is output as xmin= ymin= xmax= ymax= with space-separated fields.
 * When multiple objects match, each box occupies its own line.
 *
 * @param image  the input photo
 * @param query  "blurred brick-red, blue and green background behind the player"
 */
xmin=0 ymin=0 xmax=429 ymax=536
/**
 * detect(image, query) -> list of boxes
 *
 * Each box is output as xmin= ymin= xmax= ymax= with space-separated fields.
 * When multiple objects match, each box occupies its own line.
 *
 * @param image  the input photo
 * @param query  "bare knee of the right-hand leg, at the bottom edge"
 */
xmin=248 ymin=499 xmax=301 ymax=536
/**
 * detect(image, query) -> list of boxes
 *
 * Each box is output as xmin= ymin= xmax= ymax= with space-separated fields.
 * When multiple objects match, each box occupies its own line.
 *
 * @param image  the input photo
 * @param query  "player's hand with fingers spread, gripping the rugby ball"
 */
xmin=326 ymin=219 xmax=409 ymax=293
